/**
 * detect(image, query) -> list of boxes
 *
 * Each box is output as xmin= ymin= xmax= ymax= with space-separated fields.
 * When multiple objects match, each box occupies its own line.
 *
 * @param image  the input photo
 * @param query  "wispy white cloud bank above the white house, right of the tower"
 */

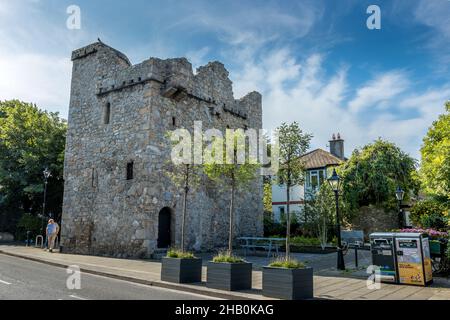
xmin=232 ymin=48 xmax=450 ymax=159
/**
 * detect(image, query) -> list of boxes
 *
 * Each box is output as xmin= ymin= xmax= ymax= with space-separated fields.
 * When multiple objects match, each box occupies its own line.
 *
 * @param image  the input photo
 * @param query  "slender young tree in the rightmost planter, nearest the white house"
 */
xmin=277 ymin=122 xmax=312 ymax=260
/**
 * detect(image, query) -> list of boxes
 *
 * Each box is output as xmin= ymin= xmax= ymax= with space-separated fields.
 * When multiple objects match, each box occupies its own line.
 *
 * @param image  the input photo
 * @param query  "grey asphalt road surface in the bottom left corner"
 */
xmin=0 ymin=254 xmax=214 ymax=300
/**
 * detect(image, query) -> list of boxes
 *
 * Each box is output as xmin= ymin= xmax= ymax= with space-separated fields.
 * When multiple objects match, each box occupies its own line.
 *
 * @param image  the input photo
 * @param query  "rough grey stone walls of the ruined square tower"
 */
xmin=61 ymin=41 xmax=263 ymax=258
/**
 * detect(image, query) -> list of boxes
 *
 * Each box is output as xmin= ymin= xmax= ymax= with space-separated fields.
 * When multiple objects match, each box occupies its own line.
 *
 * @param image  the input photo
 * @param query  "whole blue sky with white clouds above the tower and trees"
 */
xmin=0 ymin=0 xmax=450 ymax=158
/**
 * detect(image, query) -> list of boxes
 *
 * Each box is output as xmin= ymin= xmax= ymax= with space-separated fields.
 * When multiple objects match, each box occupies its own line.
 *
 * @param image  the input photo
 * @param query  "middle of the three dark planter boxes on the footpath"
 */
xmin=206 ymin=262 xmax=252 ymax=291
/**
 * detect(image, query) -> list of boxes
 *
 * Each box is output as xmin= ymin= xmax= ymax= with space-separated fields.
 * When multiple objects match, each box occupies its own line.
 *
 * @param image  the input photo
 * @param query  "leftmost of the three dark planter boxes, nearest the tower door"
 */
xmin=161 ymin=257 xmax=202 ymax=283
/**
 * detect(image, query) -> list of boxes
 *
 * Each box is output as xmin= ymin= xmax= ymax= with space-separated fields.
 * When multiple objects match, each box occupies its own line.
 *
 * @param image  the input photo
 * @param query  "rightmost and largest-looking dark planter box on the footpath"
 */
xmin=263 ymin=267 xmax=314 ymax=300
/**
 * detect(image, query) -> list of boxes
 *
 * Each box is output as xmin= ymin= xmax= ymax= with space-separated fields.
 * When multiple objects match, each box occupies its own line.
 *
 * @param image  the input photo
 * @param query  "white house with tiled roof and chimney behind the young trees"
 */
xmin=272 ymin=134 xmax=346 ymax=222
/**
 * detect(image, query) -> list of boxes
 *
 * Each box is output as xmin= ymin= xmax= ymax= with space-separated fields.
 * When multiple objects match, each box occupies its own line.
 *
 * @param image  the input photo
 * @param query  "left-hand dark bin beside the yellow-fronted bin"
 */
xmin=369 ymin=232 xmax=398 ymax=283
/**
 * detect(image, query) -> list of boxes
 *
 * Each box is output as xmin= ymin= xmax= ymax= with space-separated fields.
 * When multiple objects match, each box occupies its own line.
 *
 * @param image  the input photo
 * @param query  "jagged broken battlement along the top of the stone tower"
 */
xmin=72 ymin=42 xmax=255 ymax=119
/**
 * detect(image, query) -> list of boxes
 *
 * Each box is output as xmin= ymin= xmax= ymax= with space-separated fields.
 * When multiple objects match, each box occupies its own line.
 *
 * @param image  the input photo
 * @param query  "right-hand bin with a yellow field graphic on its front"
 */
xmin=395 ymin=233 xmax=433 ymax=286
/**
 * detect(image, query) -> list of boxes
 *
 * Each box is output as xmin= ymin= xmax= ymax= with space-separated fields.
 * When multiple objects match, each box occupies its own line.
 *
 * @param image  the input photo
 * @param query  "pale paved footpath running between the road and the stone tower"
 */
xmin=0 ymin=245 xmax=450 ymax=300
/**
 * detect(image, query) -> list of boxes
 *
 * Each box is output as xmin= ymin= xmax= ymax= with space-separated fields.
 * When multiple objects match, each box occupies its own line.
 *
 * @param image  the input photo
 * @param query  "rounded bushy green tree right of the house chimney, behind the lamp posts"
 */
xmin=338 ymin=139 xmax=419 ymax=213
